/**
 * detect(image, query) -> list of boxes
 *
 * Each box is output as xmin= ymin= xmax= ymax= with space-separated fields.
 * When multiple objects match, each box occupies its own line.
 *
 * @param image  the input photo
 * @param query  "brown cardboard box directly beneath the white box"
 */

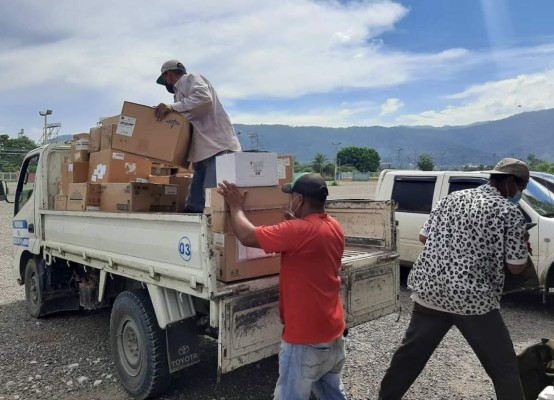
xmin=204 ymin=186 xmax=289 ymax=233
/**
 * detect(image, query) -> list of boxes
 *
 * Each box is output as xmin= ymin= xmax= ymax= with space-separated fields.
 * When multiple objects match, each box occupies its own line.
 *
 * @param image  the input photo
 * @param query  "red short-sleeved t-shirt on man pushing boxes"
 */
xmin=256 ymin=213 xmax=346 ymax=344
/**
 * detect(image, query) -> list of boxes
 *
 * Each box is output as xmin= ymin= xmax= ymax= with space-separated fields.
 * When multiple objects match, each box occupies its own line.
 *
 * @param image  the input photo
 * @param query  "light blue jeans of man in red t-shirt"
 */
xmin=273 ymin=336 xmax=346 ymax=400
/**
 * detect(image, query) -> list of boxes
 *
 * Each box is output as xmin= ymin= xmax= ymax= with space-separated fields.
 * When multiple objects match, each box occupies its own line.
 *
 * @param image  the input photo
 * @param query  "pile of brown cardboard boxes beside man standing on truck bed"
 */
xmin=54 ymin=102 xmax=191 ymax=212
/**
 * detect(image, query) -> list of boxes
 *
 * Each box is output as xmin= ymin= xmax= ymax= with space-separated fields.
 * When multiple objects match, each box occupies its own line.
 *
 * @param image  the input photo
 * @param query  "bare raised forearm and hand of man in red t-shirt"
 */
xmin=217 ymin=181 xmax=261 ymax=248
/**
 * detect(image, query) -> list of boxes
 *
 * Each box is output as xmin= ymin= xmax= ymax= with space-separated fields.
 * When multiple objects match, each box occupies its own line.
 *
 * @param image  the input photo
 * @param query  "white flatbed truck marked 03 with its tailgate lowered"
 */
xmin=0 ymin=144 xmax=399 ymax=399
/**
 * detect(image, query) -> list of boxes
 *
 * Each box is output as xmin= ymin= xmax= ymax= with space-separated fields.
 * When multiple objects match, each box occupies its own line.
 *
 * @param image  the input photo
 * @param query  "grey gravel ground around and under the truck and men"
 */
xmin=0 ymin=183 xmax=554 ymax=400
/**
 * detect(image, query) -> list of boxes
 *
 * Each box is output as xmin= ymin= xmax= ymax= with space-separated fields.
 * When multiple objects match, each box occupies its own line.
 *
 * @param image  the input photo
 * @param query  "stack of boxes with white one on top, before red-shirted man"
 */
xmin=204 ymin=152 xmax=294 ymax=282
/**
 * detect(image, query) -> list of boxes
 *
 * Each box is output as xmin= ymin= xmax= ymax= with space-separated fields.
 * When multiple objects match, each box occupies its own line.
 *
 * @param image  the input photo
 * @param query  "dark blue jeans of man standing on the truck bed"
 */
xmin=185 ymin=151 xmax=230 ymax=213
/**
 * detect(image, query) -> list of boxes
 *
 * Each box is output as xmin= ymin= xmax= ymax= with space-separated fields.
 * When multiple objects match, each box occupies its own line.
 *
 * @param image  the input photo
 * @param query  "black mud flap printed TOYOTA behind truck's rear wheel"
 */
xmin=165 ymin=317 xmax=200 ymax=373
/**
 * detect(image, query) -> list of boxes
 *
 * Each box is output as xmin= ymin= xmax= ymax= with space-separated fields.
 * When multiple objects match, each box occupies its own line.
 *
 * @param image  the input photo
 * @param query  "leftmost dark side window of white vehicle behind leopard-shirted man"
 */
xmin=392 ymin=176 xmax=437 ymax=214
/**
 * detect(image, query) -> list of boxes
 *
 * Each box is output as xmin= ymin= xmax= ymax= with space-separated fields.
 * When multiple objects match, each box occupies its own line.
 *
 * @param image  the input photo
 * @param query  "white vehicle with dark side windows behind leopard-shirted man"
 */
xmin=375 ymin=170 xmax=554 ymax=302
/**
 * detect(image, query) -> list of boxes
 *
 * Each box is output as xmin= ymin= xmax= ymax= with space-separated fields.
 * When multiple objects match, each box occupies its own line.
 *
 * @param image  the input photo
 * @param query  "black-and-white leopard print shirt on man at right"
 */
xmin=408 ymin=184 xmax=527 ymax=315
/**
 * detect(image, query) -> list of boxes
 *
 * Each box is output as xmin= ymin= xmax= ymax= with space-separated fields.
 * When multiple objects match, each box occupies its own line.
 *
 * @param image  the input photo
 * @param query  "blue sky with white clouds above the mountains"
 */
xmin=0 ymin=0 xmax=554 ymax=144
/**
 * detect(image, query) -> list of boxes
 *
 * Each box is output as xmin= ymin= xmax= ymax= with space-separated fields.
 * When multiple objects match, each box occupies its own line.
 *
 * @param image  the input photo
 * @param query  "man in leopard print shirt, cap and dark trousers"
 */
xmin=379 ymin=158 xmax=529 ymax=400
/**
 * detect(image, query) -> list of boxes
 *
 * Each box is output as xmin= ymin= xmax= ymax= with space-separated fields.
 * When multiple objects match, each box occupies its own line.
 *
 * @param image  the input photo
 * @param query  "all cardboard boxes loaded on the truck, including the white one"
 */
xmin=54 ymin=102 xmax=294 ymax=282
